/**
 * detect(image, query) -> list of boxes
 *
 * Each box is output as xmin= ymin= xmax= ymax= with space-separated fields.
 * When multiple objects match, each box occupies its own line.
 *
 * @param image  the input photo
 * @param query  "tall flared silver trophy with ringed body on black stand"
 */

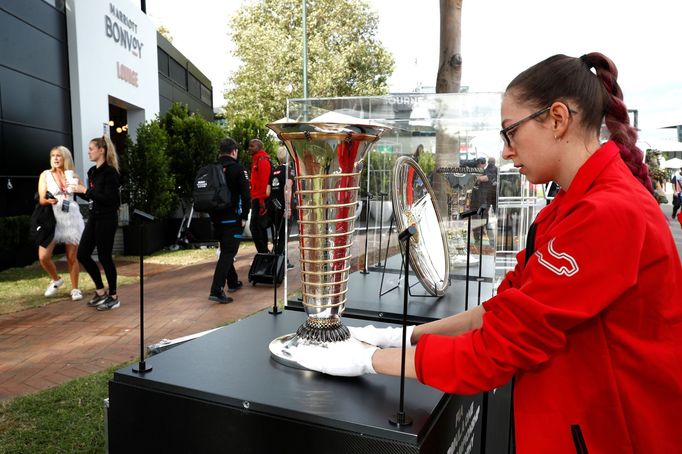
xmin=268 ymin=123 xmax=388 ymax=367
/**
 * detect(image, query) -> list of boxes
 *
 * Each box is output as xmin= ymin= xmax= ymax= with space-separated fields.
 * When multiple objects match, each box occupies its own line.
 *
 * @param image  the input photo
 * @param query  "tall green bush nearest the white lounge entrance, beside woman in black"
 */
xmin=121 ymin=118 xmax=177 ymax=218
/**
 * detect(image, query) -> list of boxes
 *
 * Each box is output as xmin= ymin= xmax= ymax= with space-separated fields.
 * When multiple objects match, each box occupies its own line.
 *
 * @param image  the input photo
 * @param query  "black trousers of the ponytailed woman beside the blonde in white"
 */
xmin=77 ymin=213 xmax=118 ymax=295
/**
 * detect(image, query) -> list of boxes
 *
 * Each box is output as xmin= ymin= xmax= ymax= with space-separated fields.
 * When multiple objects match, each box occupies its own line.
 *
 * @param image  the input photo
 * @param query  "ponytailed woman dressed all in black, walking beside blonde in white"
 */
xmin=73 ymin=136 xmax=121 ymax=311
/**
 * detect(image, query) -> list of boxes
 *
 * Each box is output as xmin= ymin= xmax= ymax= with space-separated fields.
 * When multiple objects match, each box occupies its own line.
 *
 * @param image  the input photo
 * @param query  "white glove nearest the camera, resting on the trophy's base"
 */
xmin=296 ymin=339 xmax=378 ymax=377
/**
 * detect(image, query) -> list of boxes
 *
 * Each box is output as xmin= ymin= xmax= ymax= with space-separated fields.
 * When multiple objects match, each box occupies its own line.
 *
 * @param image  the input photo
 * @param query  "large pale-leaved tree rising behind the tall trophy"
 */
xmin=225 ymin=0 xmax=394 ymax=121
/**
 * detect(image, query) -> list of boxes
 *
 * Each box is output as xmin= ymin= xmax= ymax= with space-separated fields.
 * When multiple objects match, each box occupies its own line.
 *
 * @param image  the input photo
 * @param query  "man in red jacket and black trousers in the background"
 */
xmin=249 ymin=139 xmax=272 ymax=254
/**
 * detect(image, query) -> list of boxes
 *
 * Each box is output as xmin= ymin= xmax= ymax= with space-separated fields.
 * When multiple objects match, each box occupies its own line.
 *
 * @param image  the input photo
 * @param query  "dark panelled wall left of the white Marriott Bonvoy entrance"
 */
xmin=0 ymin=0 xmax=69 ymax=216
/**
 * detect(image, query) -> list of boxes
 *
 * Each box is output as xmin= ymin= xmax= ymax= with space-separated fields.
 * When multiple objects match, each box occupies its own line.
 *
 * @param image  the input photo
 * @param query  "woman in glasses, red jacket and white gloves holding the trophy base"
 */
xmin=305 ymin=53 xmax=682 ymax=454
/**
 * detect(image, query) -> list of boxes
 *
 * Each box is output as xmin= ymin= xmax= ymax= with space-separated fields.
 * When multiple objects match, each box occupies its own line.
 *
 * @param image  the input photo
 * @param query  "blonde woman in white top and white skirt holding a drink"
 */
xmin=38 ymin=146 xmax=84 ymax=301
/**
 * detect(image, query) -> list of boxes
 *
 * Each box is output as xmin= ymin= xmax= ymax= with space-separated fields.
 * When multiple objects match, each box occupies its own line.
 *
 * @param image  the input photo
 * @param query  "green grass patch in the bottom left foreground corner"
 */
xmin=0 ymin=365 xmax=123 ymax=454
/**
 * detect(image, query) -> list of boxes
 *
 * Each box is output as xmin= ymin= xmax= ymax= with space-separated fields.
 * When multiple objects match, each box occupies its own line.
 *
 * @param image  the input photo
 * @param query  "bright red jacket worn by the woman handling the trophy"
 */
xmin=415 ymin=142 xmax=682 ymax=454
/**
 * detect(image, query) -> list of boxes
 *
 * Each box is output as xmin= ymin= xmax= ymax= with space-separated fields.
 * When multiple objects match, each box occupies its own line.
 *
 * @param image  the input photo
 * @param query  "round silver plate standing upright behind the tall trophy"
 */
xmin=391 ymin=156 xmax=450 ymax=296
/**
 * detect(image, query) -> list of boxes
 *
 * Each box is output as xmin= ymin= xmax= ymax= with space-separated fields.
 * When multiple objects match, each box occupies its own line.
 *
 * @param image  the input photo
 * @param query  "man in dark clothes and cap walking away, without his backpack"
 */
xmin=208 ymin=137 xmax=251 ymax=304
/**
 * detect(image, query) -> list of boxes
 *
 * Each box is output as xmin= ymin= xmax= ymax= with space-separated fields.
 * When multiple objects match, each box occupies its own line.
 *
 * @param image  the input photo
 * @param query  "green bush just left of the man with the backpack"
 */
xmin=159 ymin=103 xmax=225 ymax=198
